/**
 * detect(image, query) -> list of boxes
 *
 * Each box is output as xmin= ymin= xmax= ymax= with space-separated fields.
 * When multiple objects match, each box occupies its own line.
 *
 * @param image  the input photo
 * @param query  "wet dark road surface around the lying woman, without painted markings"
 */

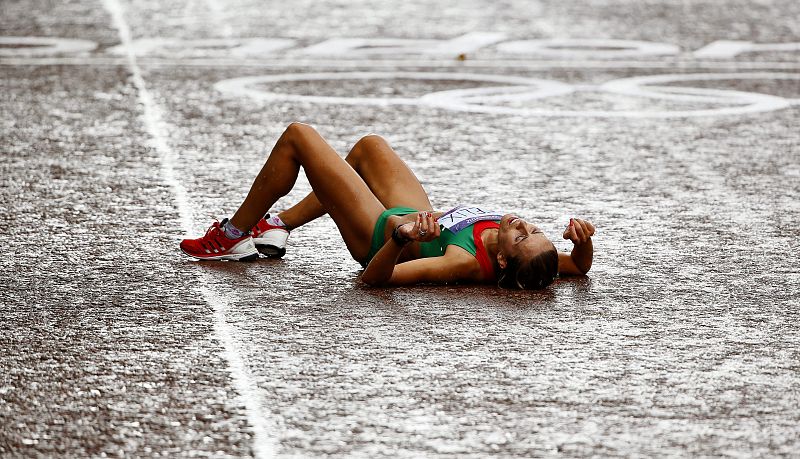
xmin=0 ymin=1 xmax=800 ymax=457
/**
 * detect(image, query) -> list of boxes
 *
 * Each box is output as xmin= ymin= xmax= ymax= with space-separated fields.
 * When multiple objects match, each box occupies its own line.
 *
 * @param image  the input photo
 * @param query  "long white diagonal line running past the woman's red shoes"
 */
xmin=103 ymin=0 xmax=277 ymax=458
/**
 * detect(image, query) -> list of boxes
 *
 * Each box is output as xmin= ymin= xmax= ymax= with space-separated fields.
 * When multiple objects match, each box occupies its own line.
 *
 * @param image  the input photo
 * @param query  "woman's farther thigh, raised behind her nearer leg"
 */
xmin=348 ymin=135 xmax=432 ymax=210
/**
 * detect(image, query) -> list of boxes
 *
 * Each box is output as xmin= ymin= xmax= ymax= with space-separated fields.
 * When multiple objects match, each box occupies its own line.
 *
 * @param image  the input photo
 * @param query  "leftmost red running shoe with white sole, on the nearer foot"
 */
xmin=181 ymin=218 xmax=258 ymax=261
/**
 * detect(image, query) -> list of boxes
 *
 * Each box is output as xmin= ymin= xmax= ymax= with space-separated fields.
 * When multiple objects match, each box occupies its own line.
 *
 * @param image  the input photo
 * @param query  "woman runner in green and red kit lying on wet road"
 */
xmin=181 ymin=123 xmax=594 ymax=289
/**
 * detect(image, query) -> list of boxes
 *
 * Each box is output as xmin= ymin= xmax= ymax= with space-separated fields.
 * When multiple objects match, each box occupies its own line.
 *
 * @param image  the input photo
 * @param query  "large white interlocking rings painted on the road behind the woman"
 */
xmin=214 ymin=72 xmax=800 ymax=118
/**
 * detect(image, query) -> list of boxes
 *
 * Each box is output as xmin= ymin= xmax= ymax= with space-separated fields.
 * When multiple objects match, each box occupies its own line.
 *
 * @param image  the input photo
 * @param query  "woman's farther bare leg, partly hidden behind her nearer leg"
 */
xmin=278 ymin=135 xmax=432 ymax=228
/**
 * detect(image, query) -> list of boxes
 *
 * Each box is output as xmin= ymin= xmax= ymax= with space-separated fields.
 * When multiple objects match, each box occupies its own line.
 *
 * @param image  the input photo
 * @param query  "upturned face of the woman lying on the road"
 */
xmin=497 ymin=214 xmax=553 ymax=268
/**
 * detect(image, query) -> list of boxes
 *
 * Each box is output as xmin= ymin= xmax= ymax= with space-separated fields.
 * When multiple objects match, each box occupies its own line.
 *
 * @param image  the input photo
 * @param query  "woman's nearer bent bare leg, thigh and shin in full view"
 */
xmin=231 ymin=123 xmax=385 ymax=260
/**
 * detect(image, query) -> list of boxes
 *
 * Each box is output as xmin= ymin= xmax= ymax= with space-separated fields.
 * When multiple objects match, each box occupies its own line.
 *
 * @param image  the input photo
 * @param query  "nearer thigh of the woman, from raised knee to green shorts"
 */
xmin=294 ymin=125 xmax=385 ymax=260
